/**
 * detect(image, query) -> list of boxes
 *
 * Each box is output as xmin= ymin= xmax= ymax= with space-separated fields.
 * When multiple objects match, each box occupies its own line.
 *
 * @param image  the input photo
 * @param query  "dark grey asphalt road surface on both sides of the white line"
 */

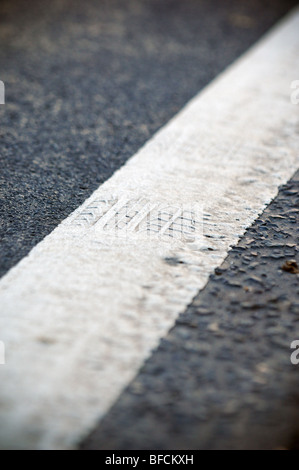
xmin=0 ymin=0 xmax=299 ymax=449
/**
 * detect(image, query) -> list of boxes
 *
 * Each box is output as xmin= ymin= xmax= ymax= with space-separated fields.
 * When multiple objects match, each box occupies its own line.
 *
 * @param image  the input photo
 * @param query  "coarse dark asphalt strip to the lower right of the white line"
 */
xmin=81 ymin=171 xmax=299 ymax=450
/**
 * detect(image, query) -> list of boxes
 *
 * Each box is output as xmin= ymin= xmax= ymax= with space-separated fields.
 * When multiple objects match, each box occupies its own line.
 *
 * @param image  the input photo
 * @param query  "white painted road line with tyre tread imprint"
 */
xmin=0 ymin=6 xmax=299 ymax=449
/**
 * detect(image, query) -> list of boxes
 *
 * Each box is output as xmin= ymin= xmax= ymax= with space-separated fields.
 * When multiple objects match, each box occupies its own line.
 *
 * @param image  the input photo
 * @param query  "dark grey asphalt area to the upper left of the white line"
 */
xmin=0 ymin=0 xmax=296 ymax=274
